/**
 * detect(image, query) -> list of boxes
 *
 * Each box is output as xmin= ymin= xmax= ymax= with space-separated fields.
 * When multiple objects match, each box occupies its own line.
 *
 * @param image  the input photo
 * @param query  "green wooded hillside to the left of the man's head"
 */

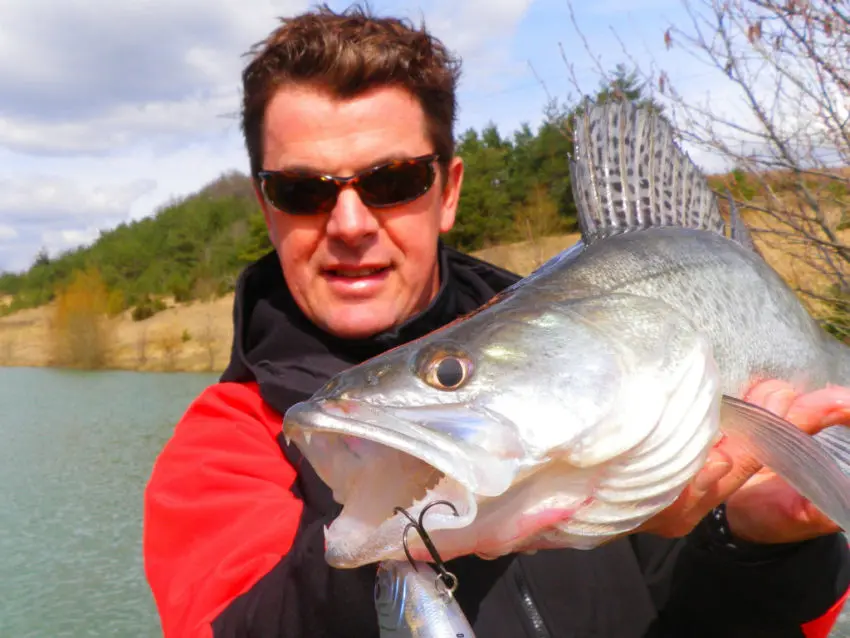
xmin=0 ymin=173 xmax=269 ymax=313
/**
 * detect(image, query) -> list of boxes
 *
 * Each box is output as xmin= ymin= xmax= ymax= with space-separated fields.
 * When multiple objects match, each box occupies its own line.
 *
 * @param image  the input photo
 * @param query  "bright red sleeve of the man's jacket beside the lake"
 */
xmin=143 ymin=383 xmax=302 ymax=638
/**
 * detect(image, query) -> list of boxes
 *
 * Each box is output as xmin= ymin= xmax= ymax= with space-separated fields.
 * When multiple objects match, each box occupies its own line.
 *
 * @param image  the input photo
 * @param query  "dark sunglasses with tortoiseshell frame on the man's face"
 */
xmin=257 ymin=153 xmax=439 ymax=215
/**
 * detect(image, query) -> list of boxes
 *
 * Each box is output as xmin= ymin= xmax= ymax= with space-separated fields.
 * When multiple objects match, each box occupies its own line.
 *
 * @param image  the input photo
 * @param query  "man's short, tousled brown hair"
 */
xmin=242 ymin=5 xmax=460 ymax=176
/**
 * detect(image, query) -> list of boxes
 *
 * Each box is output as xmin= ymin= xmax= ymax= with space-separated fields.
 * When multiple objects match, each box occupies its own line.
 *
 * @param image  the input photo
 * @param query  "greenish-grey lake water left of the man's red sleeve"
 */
xmin=0 ymin=368 xmax=850 ymax=638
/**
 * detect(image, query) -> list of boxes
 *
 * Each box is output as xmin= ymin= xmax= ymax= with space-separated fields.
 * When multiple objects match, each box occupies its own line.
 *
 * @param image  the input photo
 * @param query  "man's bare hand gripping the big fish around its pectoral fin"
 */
xmin=640 ymin=380 xmax=850 ymax=543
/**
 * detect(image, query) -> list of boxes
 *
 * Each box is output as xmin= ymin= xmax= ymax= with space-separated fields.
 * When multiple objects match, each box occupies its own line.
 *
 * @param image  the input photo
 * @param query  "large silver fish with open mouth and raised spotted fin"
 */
xmin=282 ymin=100 xmax=850 ymax=568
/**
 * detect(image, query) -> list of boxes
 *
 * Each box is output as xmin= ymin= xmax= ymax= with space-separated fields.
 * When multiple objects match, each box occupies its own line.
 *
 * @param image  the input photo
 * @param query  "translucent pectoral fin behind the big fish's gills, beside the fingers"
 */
xmin=720 ymin=396 xmax=850 ymax=531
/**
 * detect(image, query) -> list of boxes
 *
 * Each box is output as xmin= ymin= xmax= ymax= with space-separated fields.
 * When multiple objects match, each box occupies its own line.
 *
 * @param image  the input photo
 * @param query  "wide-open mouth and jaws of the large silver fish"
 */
xmin=283 ymin=399 xmax=519 ymax=568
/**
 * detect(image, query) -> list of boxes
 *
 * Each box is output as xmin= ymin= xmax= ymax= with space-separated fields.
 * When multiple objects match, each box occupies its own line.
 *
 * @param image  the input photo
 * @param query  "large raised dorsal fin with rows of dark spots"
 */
xmin=570 ymin=100 xmax=726 ymax=244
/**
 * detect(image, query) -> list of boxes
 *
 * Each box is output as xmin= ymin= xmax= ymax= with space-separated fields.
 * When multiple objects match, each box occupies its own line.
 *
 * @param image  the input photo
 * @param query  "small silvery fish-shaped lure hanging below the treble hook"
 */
xmin=375 ymin=560 xmax=475 ymax=638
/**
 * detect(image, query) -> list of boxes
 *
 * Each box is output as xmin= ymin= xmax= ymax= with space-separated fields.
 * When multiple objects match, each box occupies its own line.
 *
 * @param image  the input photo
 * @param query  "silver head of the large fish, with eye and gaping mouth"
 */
xmin=283 ymin=294 xmax=716 ymax=567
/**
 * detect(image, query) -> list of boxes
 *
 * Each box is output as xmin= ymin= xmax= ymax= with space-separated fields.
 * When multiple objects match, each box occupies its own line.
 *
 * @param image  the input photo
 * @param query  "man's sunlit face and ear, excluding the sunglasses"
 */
xmin=258 ymin=86 xmax=463 ymax=338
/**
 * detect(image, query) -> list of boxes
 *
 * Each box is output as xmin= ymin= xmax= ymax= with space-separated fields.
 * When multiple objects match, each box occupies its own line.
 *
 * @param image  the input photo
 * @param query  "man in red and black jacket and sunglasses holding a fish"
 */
xmin=144 ymin=9 xmax=850 ymax=638
